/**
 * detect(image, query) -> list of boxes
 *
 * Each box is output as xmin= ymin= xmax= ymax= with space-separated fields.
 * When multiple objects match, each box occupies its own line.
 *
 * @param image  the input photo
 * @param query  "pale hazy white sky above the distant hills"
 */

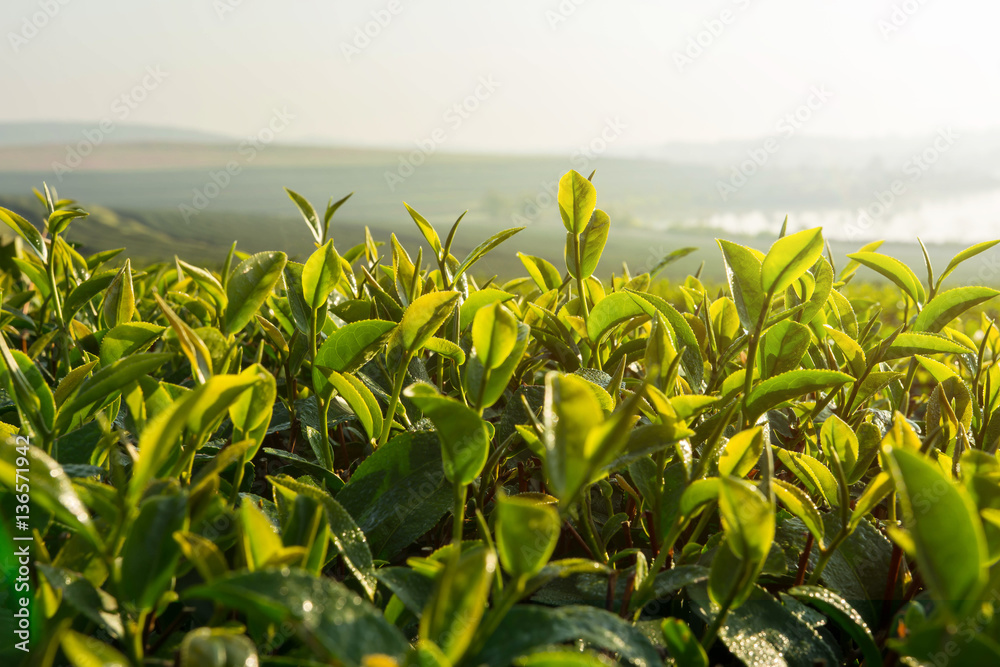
xmin=0 ymin=0 xmax=1000 ymax=151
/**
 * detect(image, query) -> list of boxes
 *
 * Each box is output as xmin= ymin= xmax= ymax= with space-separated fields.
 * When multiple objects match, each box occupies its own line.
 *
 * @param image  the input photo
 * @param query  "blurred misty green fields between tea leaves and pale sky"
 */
xmin=0 ymin=140 xmax=1000 ymax=284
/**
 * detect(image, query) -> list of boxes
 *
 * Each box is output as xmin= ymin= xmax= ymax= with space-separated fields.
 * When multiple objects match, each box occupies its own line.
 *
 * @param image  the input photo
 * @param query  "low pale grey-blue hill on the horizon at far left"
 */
xmin=0 ymin=122 xmax=233 ymax=147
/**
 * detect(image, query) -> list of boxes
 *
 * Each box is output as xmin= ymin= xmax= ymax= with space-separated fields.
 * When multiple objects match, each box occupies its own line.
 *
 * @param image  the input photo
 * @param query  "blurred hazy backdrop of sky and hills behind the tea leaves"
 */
xmin=0 ymin=0 xmax=1000 ymax=283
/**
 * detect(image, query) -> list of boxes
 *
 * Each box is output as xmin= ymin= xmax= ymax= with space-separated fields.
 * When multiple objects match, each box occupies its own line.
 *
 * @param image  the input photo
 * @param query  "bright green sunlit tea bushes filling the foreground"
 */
xmin=0 ymin=172 xmax=1000 ymax=667
